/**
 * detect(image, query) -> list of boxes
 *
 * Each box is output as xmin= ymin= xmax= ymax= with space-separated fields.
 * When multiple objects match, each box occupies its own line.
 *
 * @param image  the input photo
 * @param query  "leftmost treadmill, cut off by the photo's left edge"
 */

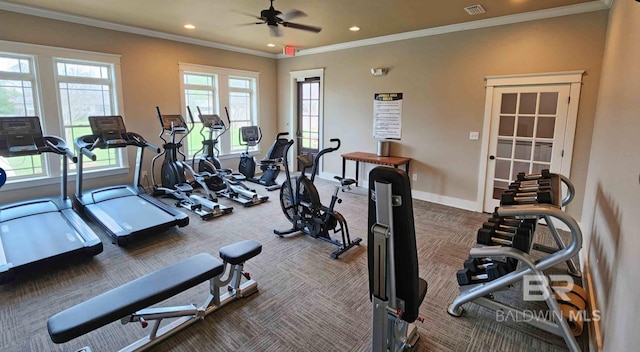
xmin=0 ymin=116 xmax=102 ymax=284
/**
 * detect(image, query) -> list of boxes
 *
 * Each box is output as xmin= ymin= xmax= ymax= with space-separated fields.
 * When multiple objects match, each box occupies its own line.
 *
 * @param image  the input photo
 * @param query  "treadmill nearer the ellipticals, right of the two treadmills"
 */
xmin=74 ymin=116 xmax=189 ymax=246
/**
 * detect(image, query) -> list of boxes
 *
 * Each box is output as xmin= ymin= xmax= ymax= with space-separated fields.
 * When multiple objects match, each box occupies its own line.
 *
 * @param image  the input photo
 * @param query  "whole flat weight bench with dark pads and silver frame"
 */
xmin=47 ymin=240 xmax=262 ymax=351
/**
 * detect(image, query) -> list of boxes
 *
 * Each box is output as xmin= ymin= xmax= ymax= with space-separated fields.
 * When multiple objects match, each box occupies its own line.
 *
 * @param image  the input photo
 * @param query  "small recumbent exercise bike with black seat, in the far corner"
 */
xmin=238 ymin=126 xmax=289 ymax=191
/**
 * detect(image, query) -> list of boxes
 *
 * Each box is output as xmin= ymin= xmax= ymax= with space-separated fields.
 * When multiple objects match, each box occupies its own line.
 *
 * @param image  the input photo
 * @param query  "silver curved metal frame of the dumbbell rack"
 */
xmin=447 ymin=174 xmax=582 ymax=351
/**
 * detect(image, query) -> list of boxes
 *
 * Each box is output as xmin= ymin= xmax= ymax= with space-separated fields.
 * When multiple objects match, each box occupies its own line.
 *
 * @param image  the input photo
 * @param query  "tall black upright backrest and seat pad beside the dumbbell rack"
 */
xmin=367 ymin=166 xmax=427 ymax=323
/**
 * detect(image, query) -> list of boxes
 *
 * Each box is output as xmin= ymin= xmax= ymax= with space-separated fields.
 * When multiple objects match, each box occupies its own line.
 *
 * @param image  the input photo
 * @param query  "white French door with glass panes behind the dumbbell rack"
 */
xmin=483 ymin=84 xmax=577 ymax=212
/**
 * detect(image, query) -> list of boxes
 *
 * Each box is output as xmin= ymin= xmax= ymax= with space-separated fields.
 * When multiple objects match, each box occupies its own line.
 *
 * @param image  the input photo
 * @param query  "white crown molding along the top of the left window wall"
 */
xmin=0 ymin=1 xmax=277 ymax=59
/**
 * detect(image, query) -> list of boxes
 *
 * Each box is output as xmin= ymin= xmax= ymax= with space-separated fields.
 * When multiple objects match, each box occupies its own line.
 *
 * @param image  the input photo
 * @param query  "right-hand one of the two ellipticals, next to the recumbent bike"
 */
xmin=187 ymin=106 xmax=269 ymax=207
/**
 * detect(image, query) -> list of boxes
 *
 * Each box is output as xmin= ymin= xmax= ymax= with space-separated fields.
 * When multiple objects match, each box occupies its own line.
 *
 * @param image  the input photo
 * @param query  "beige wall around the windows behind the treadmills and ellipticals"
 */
xmin=0 ymin=11 xmax=277 ymax=202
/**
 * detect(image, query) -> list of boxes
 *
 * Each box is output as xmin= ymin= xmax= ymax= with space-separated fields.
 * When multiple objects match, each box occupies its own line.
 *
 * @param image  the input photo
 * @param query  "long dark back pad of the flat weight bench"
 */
xmin=47 ymin=253 xmax=224 ymax=343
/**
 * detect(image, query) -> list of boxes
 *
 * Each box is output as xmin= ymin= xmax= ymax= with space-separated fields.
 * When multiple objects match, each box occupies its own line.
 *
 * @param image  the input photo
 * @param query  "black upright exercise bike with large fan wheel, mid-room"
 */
xmin=273 ymin=138 xmax=362 ymax=259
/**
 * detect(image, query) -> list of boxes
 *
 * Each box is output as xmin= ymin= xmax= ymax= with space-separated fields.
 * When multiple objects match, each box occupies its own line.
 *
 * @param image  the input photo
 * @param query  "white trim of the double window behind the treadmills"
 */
xmin=0 ymin=40 xmax=129 ymax=190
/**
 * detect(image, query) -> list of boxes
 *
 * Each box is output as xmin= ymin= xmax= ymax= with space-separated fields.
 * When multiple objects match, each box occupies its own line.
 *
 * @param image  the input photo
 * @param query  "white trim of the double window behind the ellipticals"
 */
xmin=178 ymin=62 xmax=260 ymax=160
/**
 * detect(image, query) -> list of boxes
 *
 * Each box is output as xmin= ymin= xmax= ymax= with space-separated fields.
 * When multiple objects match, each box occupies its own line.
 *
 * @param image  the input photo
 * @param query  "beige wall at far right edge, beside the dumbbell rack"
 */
xmin=582 ymin=0 xmax=640 ymax=351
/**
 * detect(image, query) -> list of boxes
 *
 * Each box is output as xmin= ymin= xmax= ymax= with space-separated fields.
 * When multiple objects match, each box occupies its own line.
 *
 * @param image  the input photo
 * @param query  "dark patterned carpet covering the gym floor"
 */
xmin=0 ymin=175 xmax=584 ymax=352
